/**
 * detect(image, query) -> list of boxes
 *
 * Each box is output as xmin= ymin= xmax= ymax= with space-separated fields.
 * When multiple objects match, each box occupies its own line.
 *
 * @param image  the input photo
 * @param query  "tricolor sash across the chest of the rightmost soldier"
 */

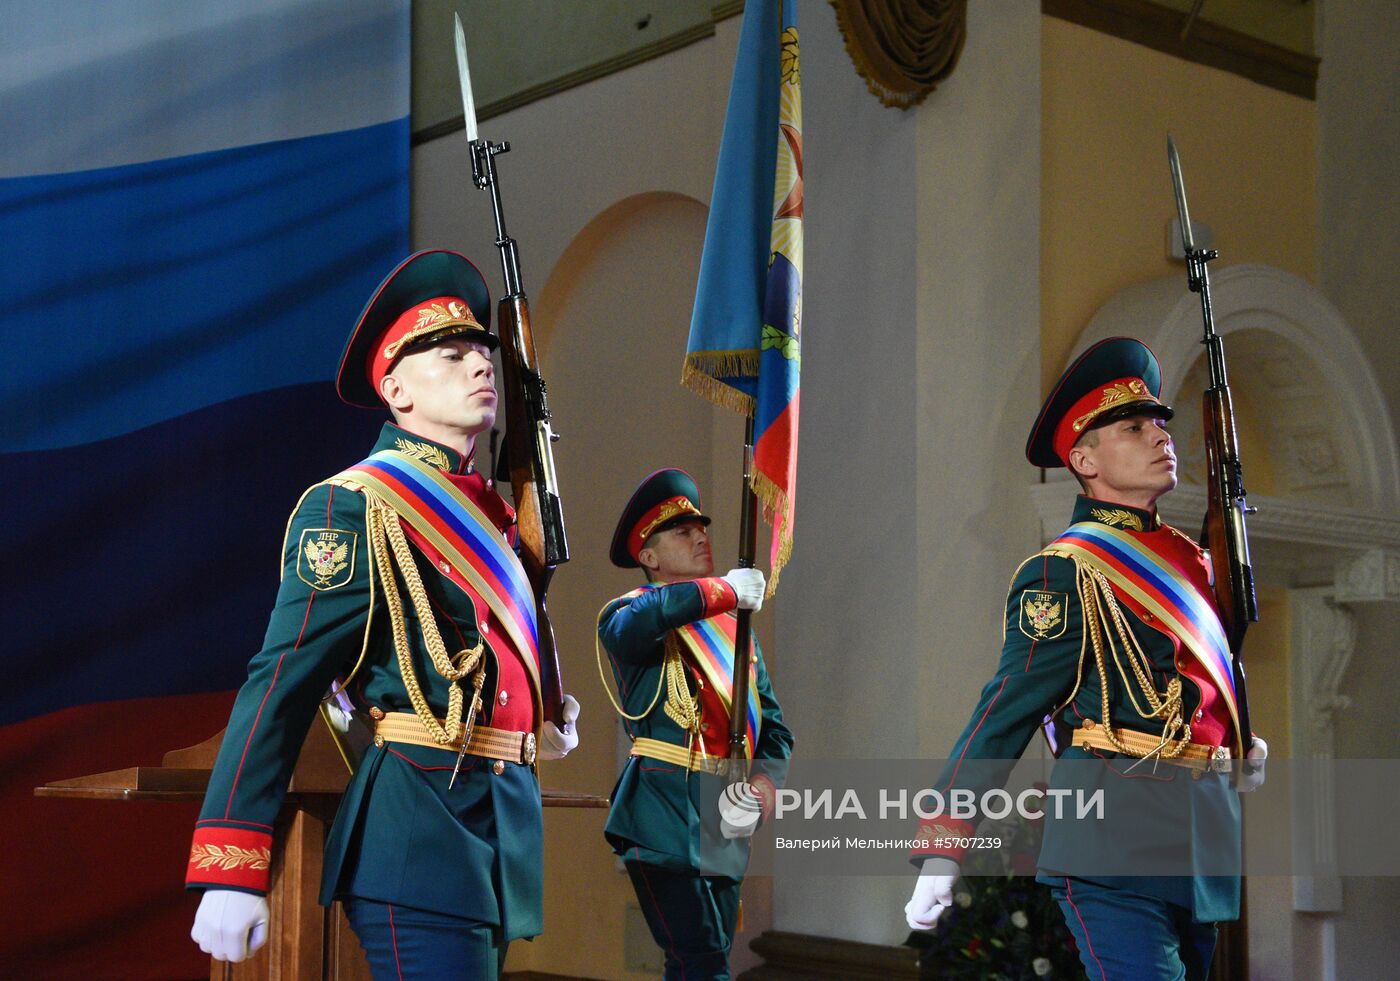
xmin=1046 ymin=522 xmax=1245 ymax=746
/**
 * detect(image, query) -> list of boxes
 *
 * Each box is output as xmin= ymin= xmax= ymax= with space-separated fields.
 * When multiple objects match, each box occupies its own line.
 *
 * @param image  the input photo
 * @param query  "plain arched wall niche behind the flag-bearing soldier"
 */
xmin=523 ymin=192 xmax=771 ymax=977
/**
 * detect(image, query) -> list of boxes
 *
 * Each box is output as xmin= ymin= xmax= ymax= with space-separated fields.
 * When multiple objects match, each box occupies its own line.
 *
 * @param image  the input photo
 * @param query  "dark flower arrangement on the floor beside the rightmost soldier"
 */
xmin=910 ymin=789 xmax=1085 ymax=981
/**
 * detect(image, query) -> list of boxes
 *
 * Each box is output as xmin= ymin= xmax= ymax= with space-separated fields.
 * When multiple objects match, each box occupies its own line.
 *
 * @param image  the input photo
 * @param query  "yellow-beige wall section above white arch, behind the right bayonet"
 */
xmin=1040 ymin=17 xmax=1317 ymax=390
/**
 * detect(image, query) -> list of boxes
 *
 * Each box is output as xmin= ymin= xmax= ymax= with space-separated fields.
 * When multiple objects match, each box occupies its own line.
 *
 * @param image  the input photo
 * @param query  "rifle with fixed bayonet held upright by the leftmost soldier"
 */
xmin=455 ymin=17 xmax=568 ymax=729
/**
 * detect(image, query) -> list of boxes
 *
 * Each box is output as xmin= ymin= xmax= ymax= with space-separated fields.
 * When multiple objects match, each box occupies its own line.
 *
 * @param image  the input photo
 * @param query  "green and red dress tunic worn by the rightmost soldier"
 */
xmin=916 ymin=497 xmax=1239 ymax=922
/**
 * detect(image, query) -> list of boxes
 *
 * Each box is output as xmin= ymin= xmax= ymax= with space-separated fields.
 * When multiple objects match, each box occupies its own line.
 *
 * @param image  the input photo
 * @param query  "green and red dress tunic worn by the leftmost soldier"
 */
xmin=188 ymin=424 xmax=543 ymax=940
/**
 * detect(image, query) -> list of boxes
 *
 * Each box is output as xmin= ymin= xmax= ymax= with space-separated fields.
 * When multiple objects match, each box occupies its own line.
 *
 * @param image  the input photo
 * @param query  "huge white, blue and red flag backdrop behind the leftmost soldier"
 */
xmin=0 ymin=0 xmax=409 ymax=978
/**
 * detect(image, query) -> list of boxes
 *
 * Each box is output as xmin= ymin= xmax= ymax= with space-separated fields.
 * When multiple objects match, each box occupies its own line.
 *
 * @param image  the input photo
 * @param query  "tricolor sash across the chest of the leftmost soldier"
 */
xmin=332 ymin=449 xmax=540 ymax=705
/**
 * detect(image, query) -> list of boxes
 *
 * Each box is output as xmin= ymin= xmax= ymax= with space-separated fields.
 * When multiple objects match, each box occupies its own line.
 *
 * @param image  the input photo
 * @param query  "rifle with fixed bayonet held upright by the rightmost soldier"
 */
xmin=1166 ymin=136 xmax=1259 ymax=753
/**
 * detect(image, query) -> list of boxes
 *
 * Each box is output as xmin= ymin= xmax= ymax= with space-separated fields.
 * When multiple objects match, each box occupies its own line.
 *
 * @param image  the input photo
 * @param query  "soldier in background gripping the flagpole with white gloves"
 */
xmin=598 ymin=469 xmax=792 ymax=981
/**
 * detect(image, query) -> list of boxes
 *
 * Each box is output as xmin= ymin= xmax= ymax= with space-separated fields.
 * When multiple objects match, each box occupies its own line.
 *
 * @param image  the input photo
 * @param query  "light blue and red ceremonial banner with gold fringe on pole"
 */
xmin=682 ymin=0 xmax=802 ymax=595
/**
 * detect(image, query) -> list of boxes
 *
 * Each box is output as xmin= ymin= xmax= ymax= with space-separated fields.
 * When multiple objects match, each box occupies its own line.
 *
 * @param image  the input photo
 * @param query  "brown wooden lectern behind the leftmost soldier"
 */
xmin=34 ymin=722 xmax=608 ymax=981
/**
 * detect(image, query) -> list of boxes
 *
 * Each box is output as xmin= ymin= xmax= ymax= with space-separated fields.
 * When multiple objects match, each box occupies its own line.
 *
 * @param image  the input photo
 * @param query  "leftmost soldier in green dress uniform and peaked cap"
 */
xmin=186 ymin=250 xmax=578 ymax=978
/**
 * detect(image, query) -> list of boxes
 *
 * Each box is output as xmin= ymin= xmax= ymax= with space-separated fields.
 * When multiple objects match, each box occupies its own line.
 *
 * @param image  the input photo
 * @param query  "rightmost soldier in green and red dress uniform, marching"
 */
xmin=904 ymin=337 xmax=1268 ymax=981
